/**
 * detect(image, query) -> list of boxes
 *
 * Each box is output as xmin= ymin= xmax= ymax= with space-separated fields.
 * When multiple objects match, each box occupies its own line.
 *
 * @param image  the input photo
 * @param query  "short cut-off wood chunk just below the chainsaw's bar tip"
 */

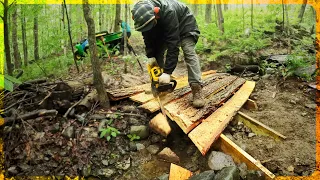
xmin=149 ymin=113 xmax=171 ymax=137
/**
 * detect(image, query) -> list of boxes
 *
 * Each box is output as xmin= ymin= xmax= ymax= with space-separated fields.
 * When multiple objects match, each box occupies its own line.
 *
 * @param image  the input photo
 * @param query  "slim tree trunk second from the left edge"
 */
xmin=12 ymin=7 xmax=21 ymax=69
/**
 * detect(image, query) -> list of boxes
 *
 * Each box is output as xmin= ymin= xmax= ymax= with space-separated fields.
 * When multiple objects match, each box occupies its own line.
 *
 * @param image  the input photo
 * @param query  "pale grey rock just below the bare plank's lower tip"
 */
xmin=208 ymin=151 xmax=235 ymax=171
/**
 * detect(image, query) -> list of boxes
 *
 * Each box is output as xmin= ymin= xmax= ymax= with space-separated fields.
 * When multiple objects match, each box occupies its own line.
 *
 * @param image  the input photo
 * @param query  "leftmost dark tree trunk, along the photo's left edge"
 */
xmin=2 ymin=0 xmax=13 ymax=75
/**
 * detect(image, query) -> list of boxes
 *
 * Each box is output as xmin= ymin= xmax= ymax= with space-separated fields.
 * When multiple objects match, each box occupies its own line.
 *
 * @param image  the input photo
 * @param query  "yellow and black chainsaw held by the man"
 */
xmin=147 ymin=59 xmax=177 ymax=115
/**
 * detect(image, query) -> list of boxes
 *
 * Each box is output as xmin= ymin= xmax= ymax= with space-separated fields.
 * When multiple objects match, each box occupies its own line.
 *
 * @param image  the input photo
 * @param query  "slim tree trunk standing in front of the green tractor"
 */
xmin=82 ymin=0 xmax=110 ymax=108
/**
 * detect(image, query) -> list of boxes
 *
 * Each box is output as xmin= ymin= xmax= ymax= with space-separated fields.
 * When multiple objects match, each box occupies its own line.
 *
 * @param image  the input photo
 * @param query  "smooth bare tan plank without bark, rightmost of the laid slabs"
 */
xmin=188 ymin=81 xmax=255 ymax=155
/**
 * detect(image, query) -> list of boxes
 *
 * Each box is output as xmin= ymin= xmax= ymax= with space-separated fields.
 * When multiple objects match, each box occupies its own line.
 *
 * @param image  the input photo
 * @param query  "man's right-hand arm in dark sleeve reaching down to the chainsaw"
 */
xmin=162 ymin=10 xmax=180 ymax=74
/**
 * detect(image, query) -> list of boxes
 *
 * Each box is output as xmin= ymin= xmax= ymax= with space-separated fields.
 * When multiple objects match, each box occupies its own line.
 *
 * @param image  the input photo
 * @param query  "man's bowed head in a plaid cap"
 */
xmin=131 ymin=0 xmax=159 ymax=32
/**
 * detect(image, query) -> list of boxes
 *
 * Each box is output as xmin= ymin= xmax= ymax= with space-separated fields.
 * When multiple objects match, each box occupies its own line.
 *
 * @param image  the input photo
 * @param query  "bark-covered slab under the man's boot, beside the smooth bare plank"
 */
xmin=164 ymin=76 xmax=245 ymax=134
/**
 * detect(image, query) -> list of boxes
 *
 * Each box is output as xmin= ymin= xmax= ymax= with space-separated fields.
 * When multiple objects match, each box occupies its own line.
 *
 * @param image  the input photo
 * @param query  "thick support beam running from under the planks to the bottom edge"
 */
xmin=216 ymin=134 xmax=275 ymax=179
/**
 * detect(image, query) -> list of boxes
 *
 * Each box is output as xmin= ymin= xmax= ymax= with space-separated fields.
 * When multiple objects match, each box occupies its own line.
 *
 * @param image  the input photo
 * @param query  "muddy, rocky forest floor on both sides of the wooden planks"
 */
xmin=2 ymin=33 xmax=316 ymax=180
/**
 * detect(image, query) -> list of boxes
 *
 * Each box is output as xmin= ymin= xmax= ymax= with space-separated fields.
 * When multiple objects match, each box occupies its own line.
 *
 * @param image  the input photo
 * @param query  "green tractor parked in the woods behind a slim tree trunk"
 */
xmin=75 ymin=31 xmax=122 ymax=60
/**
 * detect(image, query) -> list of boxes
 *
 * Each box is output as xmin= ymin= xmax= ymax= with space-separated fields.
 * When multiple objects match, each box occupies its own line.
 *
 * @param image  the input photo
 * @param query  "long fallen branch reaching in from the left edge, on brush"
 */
xmin=0 ymin=109 xmax=58 ymax=126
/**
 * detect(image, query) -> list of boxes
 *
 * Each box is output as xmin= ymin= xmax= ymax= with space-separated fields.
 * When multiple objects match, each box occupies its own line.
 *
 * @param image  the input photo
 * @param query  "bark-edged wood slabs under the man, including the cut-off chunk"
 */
xmin=109 ymin=71 xmax=255 ymax=155
